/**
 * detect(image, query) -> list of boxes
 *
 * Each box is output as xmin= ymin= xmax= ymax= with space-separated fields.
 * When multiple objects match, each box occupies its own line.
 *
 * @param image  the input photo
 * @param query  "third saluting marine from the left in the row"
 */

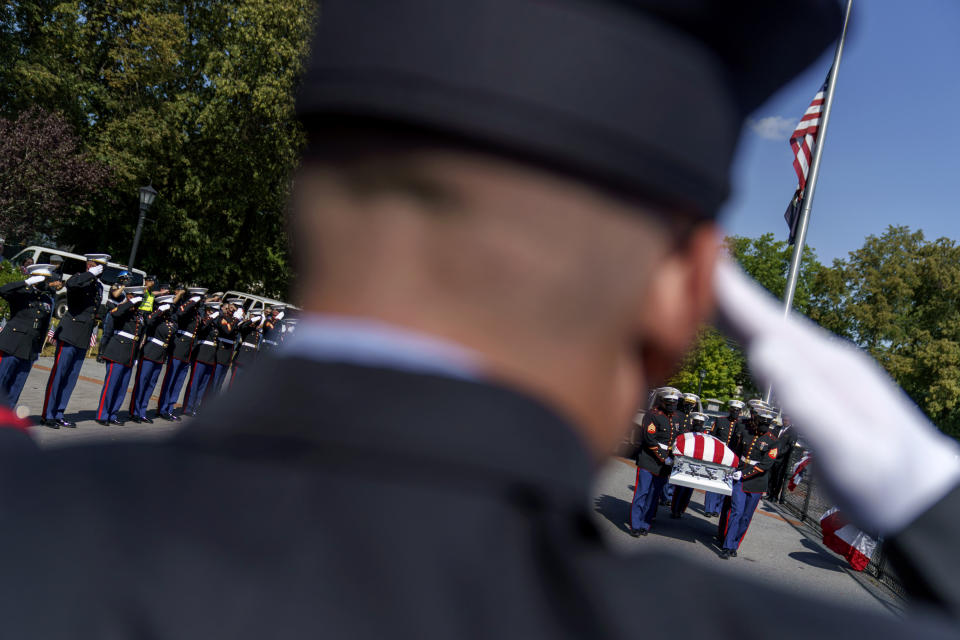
xmin=97 ymin=287 xmax=143 ymax=426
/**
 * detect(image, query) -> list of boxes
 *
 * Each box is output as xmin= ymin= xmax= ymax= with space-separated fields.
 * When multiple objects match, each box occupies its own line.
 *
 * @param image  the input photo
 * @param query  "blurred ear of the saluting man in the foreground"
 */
xmin=638 ymin=224 xmax=720 ymax=387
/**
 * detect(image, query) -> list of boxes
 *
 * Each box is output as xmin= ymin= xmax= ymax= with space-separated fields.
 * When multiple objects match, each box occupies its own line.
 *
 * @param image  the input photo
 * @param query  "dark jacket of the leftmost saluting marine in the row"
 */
xmin=0 ymin=280 xmax=53 ymax=362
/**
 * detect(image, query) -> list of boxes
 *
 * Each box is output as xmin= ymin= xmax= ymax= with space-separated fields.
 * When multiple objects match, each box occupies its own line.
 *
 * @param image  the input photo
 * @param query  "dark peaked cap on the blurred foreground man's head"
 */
xmin=297 ymin=0 xmax=841 ymax=217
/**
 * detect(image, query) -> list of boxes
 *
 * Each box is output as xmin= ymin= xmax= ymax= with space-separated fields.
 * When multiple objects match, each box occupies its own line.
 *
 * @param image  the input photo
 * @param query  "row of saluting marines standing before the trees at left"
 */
xmin=0 ymin=254 xmax=293 ymax=429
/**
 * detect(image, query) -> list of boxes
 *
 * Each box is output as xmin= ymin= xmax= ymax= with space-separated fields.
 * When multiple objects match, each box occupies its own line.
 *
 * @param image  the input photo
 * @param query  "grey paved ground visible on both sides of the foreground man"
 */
xmin=11 ymin=358 xmax=903 ymax=613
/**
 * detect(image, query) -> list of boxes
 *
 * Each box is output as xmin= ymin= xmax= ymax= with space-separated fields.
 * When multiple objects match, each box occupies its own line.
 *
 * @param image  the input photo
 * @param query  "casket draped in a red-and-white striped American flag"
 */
xmin=670 ymin=433 xmax=740 ymax=496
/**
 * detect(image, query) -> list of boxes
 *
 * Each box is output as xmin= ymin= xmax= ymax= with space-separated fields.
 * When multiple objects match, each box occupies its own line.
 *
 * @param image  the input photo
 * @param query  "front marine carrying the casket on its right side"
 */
xmin=719 ymin=405 xmax=779 ymax=559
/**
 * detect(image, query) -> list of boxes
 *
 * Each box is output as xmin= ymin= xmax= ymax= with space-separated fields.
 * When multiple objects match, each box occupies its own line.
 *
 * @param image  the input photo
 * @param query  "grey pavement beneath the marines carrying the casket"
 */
xmin=595 ymin=458 xmax=904 ymax=614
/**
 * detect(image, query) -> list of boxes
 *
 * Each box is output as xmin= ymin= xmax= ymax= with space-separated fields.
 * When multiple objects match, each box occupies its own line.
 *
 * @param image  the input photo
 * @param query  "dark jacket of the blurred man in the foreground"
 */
xmin=0 ymin=359 xmax=960 ymax=640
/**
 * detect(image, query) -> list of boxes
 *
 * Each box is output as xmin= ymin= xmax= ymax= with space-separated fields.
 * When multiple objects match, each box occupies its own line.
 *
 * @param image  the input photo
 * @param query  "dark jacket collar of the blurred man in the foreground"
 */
xmin=179 ymin=360 xmax=594 ymax=505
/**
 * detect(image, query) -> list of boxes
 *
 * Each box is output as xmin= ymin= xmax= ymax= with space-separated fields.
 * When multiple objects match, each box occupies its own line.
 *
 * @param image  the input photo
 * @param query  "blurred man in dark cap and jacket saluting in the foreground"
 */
xmin=0 ymin=0 xmax=960 ymax=639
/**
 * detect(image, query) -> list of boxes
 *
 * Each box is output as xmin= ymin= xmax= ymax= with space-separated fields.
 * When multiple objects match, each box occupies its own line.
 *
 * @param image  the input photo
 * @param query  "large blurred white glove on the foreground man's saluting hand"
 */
xmin=714 ymin=260 xmax=960 ymax=535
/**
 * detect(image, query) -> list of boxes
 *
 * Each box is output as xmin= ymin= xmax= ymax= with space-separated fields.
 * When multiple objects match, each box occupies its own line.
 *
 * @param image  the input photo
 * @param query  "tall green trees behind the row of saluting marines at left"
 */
xmin=0 ymin=0 xmax=315 ymax=295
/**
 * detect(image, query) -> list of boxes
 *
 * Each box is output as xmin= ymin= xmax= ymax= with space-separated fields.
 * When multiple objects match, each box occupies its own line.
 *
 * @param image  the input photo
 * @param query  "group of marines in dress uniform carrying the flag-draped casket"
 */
xmin=628 ymin=387 xmax=797 ymax=559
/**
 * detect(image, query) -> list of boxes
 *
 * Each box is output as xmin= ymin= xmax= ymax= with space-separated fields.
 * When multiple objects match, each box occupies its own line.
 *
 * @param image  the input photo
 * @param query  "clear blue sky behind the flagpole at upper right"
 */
xmin=722 ymin=0 xmax=960 ymax=262
